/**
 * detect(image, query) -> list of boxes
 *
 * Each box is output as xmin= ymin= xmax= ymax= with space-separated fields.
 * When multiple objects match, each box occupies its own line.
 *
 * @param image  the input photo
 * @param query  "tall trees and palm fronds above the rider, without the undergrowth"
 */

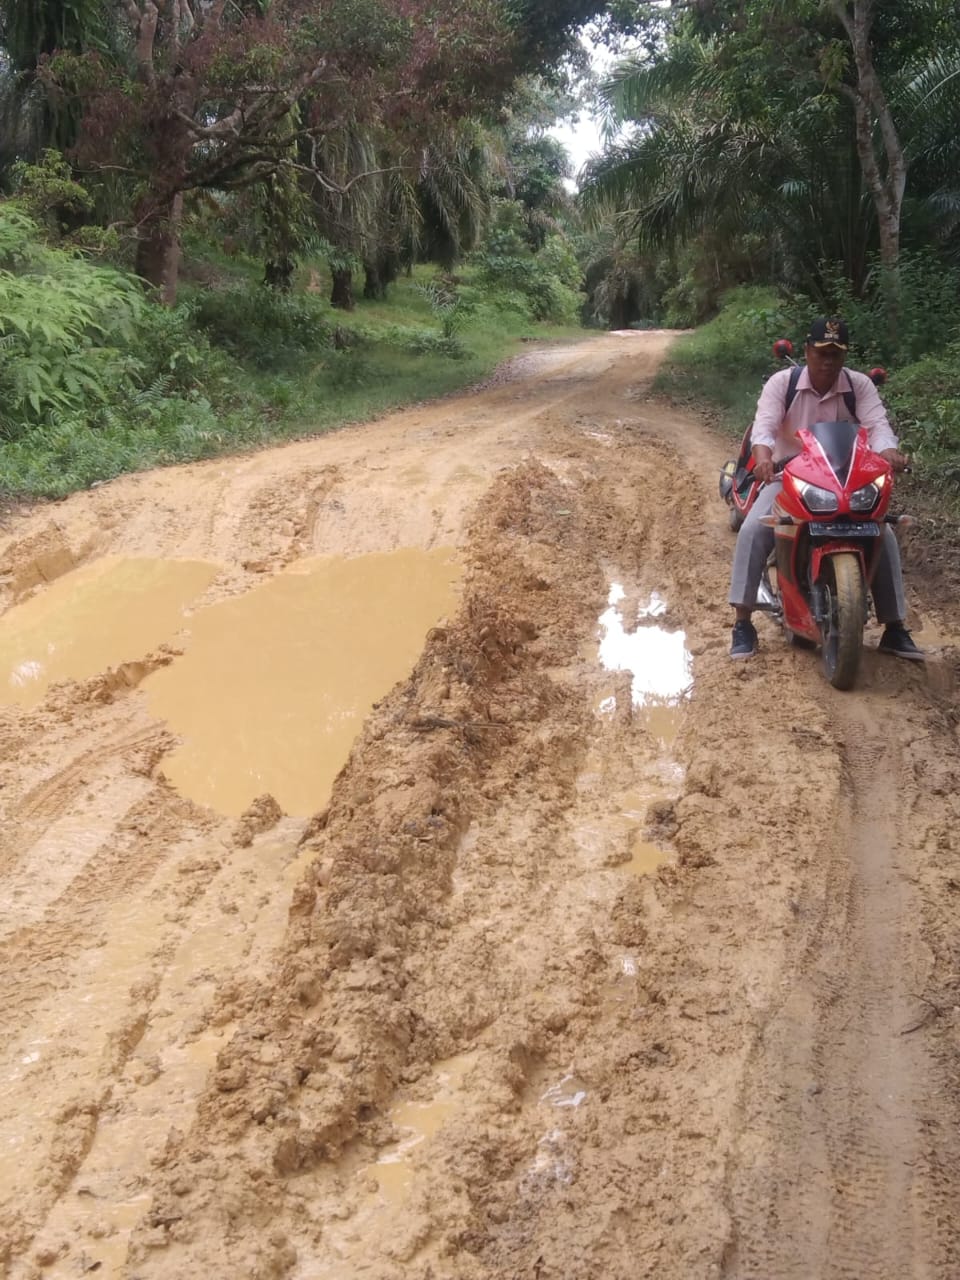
xmin=585 ymin=0 xmax=960 ymax=343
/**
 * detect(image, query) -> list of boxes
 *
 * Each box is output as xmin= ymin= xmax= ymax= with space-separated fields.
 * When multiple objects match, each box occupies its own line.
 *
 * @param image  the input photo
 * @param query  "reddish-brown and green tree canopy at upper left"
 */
xmin=0 ymin=0 xmax=611 ymax=300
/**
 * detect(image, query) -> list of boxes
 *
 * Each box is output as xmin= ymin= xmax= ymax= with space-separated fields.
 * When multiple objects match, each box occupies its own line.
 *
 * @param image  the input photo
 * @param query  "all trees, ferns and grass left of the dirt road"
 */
xmin=0 ymin=0 xmax=603 ymax=495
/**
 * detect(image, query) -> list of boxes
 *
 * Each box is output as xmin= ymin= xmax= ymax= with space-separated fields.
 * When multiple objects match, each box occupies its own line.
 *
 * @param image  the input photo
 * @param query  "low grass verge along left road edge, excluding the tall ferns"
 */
xmin=0 ymin=253 xmax=585 ymax=499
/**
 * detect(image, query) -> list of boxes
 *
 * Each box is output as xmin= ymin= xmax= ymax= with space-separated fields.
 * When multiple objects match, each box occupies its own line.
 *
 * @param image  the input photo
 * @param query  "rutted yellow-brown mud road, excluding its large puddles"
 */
xmin=0 ymin=334 xmax=960 ymax=1280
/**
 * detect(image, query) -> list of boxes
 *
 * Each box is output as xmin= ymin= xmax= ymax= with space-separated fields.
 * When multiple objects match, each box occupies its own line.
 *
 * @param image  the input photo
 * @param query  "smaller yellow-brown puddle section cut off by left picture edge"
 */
xmin=0 ymin=557 xmax=220 ymax=707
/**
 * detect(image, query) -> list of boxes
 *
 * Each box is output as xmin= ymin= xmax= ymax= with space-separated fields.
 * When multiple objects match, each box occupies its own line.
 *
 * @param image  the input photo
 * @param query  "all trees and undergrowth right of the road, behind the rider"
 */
xmin=582 ymin=0 xmax=960 ymax=499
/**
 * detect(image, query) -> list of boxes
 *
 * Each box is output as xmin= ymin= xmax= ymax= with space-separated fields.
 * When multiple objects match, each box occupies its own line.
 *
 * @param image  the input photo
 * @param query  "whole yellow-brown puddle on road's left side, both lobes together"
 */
xmin=0 ymin=548 xmax=461 ymax=817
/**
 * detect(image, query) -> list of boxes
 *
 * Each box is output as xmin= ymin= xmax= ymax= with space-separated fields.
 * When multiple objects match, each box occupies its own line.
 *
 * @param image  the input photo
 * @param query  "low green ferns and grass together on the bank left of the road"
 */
xmin=0 ymin=202 xmax=583 ymax=497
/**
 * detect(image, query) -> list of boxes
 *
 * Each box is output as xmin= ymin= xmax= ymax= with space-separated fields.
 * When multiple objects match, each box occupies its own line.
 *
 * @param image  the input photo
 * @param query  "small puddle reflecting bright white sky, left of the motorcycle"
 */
xmin=599 ymin=582 xmax=694 ymax=710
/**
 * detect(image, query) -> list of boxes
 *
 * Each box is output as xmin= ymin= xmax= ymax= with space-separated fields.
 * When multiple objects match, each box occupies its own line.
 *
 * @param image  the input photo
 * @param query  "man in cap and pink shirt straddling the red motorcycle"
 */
xmin=730 ymin=319 xmax=923 ymax=662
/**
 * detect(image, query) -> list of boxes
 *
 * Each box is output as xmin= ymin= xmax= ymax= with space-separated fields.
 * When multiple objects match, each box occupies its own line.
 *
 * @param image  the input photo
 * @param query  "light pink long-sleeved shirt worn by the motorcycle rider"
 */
xmin=750 ymin=369 xmax=899 ymax=462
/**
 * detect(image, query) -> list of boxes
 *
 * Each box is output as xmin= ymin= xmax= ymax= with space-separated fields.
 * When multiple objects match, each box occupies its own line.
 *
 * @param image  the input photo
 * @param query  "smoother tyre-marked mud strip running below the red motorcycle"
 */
xmin=723 ymin=675 xmax=960 ymax=1280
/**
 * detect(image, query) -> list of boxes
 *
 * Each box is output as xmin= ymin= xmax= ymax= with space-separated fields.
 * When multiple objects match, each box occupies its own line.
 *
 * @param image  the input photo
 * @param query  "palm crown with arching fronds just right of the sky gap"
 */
xmin=581 ymin=40 xmax=873 ymax=299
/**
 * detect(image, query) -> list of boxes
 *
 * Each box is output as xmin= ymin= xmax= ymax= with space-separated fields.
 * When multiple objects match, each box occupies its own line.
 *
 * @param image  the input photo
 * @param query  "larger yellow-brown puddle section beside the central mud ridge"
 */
xmin=143 ymin=548 xmax=461 ymax=817
